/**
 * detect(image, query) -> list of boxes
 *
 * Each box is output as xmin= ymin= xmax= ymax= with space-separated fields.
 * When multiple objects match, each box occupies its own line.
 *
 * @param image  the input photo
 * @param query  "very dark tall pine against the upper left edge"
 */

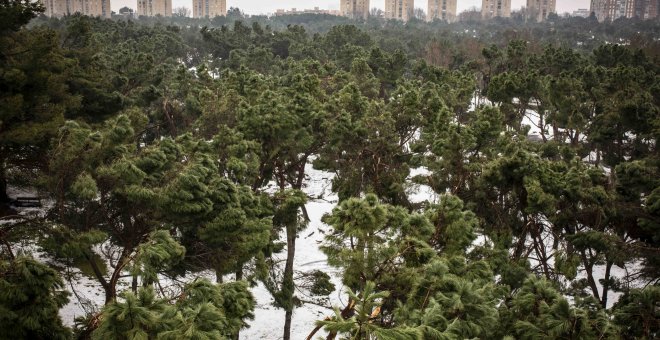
xmin=0 ymin=0 xmax=80 ymax=204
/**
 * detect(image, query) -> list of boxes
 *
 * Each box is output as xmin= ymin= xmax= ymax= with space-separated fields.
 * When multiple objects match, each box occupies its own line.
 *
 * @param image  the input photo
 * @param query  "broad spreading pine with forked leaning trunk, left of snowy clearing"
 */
xmin=42 ymin=110 xmax=271 ymax=303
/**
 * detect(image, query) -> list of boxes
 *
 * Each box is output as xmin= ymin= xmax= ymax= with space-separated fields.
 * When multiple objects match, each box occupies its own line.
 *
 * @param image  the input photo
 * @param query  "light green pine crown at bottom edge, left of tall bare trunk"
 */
xmin=92 ymin=279 xmax=255 ymax=339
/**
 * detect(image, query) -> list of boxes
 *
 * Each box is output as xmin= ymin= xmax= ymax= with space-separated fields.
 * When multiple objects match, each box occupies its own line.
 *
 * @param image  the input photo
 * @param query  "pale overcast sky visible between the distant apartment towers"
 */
xmin=111 ymin=0 xmax=589 ymax=14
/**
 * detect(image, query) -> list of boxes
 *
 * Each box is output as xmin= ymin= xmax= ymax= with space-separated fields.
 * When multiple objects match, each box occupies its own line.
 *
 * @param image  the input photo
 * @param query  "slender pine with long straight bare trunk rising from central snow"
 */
xmin=232 ymin=62 xmax=326 ymax=339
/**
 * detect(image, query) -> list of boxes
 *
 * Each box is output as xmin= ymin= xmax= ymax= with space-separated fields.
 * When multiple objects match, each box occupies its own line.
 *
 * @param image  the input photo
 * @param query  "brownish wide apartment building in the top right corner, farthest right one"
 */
xmin=591 ymin=0 xmax=659 ymax=21
